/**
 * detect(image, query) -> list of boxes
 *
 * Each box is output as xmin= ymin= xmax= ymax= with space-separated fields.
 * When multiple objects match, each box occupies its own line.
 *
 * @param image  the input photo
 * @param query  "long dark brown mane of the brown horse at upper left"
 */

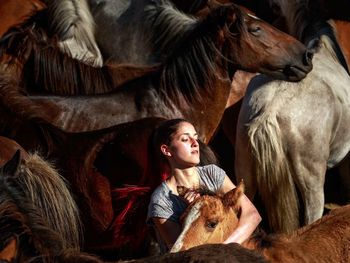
xmin=0 ymin=10 xmax=119 ymax=95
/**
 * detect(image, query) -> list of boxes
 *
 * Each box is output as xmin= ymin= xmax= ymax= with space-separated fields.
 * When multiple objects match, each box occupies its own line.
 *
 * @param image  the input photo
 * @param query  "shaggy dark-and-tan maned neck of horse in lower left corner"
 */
xmin=0 ymin=153 xmax=81 ymax=262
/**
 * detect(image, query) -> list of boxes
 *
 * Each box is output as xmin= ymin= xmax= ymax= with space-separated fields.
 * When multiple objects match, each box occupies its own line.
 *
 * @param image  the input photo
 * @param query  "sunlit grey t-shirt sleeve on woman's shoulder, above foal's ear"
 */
xmin=201 ymin=164 xmax=226 ymax=192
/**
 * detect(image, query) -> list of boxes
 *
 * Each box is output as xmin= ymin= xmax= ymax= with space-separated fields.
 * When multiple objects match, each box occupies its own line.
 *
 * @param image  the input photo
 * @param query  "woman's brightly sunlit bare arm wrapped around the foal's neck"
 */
xmin=220 ymin=175 xmax=261 ymax=244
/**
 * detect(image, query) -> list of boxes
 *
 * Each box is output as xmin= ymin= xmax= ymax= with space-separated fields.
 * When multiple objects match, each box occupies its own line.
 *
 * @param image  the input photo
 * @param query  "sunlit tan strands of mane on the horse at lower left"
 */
xmin=18 ymin=153 xmax=82 ymax=250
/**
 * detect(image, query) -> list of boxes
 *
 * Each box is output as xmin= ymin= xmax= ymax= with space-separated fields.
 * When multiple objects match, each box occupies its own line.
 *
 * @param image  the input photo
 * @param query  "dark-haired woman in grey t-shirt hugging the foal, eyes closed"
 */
xmin=147 ymin=119 xmax=261 ymax=252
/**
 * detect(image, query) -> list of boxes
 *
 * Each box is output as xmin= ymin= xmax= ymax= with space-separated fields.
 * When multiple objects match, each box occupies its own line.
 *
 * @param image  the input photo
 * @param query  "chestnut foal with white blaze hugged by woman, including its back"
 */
xmin=171 ymin=183 xmax=350 ymax=263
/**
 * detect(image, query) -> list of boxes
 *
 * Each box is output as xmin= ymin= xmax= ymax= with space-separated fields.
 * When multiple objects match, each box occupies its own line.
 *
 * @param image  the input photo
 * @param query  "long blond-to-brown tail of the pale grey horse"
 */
xmin=248 ymin=111 xmax=299 ymax=233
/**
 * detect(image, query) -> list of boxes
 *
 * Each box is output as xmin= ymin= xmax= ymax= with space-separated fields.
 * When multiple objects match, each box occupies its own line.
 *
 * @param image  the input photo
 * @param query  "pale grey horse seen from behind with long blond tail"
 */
xmin=235 ymin=1 xmax=350 ymax=235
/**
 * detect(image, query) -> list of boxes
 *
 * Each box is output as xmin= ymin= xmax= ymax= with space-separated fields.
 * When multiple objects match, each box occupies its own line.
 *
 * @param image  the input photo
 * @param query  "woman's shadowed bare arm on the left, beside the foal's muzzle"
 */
xmin=152 ymin=217 xmax=181 ymax=249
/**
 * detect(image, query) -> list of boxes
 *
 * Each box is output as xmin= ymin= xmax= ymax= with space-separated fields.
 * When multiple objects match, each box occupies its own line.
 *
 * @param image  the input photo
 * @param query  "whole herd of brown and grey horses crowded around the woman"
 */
xmin=0 ymin=0 xmax=350 ymax=262
